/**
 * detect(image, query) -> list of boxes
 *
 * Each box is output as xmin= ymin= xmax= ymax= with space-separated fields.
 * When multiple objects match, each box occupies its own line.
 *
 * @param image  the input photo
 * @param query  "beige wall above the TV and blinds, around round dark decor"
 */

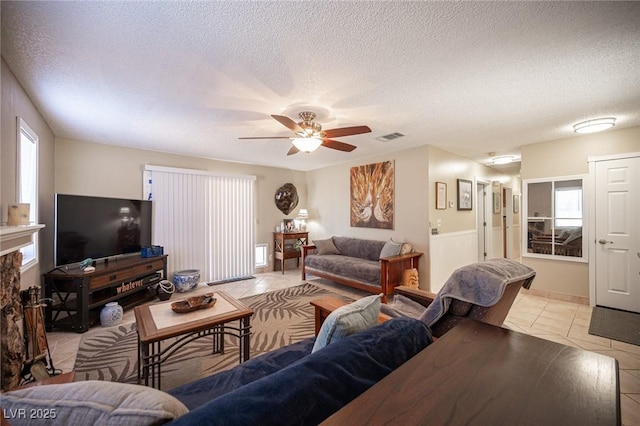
xmin=55 ymin=138 xmax=307 ymax=272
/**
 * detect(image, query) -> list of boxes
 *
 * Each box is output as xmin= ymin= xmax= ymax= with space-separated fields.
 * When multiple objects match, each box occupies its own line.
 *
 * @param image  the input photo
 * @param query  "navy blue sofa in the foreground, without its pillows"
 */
xmin=168 ymin=318 xmax=432 ymax=425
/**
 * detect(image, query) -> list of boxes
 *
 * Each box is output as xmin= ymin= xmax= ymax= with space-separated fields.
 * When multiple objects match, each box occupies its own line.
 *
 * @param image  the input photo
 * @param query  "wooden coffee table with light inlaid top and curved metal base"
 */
xmin=134 ymin=291 xmax=253 ymax=389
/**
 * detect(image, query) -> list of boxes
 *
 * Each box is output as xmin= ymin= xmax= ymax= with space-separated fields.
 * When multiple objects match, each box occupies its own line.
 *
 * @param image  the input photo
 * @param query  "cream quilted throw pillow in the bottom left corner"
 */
xmin=2 ymin=380 xmax=189 ymax=425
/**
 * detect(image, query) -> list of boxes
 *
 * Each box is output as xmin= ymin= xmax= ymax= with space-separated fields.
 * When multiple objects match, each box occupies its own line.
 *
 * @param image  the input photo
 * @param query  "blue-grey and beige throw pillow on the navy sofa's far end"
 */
xmin=311 ymin=294 xmax=382 ymax=352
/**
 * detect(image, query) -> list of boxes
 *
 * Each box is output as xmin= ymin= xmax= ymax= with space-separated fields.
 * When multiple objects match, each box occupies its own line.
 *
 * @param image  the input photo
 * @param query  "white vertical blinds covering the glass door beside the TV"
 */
xmin=144 ymin=165 xmax=256 ymax=281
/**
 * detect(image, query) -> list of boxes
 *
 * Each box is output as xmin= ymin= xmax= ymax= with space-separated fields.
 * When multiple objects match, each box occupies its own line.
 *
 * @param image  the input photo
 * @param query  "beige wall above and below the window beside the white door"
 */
xmin=520 ymin=127 xmax=640 ymax=298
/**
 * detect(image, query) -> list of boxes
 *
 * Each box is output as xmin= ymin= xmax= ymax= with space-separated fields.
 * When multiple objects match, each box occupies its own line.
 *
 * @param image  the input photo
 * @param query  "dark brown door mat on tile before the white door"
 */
xmin=589 ymin=306 xmax=640 ymax=346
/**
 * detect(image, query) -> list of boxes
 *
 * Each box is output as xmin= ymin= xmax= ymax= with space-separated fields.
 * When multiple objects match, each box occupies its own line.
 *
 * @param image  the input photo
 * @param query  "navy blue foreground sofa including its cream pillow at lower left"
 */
xmin=0 ymin=312 xmax=432 ymax=426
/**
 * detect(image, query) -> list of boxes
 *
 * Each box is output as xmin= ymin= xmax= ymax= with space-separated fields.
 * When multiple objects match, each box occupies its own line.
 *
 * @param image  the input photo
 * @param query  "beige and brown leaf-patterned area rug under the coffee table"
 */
xmin=74 ymin=283 xmax=348 ymax=390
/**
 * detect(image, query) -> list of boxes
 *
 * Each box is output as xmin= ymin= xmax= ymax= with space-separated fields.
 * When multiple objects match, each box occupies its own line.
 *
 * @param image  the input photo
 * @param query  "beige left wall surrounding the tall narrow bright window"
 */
xmin=0 ymin=59 xmax=54 ymax=288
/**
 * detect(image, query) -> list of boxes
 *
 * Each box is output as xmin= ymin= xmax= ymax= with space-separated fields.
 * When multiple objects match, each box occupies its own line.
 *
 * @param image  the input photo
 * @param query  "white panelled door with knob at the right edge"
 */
xmin=595 ymin=157 xmax=640 ymax=312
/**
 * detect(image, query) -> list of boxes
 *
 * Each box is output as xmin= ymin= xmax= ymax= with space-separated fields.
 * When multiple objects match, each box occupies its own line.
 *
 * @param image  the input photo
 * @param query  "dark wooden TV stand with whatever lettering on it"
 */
xmin=44 ymin=255 xmax=167 ymax=333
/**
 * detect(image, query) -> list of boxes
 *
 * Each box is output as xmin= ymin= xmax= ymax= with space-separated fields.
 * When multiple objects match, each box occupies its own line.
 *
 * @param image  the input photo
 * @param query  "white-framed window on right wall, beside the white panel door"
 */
xmin=523 ymin=177 xmax=587 ymax=261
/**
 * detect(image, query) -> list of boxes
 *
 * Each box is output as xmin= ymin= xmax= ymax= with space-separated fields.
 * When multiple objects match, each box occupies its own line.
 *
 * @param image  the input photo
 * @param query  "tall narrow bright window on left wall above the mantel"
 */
xmin=17 ymin=117 xmax=38 ymax=270
